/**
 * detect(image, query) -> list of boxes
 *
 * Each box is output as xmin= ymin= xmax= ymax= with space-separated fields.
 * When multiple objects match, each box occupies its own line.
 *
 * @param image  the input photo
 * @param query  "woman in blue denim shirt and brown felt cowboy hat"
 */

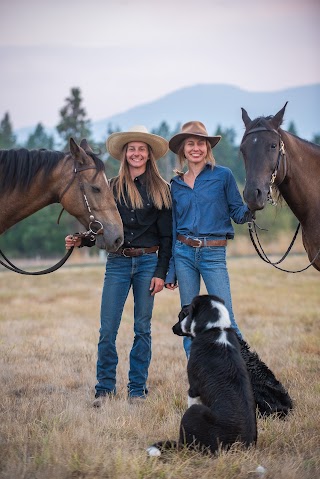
xmin=165 ymin=121 xmax=251 ymax=356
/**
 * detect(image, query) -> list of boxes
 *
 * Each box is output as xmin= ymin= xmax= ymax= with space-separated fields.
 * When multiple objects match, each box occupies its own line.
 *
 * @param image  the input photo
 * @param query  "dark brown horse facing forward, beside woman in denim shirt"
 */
xmin=240 ymin=103 xmax=320 ymax=271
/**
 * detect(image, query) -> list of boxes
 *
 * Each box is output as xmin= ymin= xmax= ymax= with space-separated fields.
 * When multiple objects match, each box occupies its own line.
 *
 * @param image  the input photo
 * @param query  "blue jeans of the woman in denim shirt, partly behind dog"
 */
xmin=174 ymin=240 xmax=242 ymax=357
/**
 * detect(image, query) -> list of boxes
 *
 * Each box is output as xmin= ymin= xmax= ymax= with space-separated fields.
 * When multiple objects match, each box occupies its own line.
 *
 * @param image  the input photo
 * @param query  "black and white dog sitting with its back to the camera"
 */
xmin=148 ymin=295 xmax=257 ymax=456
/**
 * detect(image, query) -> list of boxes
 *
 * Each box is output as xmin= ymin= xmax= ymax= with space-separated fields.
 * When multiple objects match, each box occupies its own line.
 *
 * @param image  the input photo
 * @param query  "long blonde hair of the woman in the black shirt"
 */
xmin=112 ymin=144 xmax=172 ymax=210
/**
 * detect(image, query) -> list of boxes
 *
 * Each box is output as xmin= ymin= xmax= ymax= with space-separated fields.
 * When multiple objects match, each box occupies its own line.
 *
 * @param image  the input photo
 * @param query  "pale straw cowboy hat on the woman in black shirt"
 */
xmin=106 ymin=125 xmax=169 ymax=160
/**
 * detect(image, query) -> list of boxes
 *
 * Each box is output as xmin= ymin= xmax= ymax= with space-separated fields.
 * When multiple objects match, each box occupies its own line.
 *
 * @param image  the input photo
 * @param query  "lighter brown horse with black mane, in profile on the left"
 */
xmin=0 ymin=138 xmax=123 ymax=251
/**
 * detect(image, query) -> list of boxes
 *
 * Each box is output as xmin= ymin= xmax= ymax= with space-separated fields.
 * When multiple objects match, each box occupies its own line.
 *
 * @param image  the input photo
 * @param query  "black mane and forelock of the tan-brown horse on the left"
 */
xmin=0 ymin=148 xmax=104 ymax=194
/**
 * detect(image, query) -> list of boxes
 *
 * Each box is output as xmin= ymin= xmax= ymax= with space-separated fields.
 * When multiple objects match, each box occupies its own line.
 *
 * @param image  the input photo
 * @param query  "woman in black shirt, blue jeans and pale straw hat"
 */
xmin=66 ymin=126 xmax=172 ymax=407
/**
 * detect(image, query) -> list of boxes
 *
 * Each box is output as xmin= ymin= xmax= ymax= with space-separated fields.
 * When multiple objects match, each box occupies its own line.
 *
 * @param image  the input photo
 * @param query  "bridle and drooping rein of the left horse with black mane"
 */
xmin=0 ymin=155 xmax=103 ymax=276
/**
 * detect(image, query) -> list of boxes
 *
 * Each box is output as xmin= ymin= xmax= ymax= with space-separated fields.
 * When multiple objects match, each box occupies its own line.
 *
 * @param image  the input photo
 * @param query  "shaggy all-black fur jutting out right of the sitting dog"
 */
xmin=239 ymin=339 xmax=293 ymax=418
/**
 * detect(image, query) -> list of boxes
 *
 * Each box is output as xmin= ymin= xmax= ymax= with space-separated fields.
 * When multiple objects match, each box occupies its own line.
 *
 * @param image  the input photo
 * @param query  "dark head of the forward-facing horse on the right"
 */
xmin=240 ymin=102 xmax=288 ymax=211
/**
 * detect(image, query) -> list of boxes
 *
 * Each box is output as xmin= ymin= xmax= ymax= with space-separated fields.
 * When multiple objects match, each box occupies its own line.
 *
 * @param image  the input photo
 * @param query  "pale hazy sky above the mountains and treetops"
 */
xmin=0 ymin=0 xmax=320 ymax=129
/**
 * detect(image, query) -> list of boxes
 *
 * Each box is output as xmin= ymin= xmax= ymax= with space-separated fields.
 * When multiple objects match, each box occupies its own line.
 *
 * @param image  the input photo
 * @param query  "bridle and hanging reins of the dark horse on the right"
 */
xmin=245 ymin=126 xmax=320 ymax=273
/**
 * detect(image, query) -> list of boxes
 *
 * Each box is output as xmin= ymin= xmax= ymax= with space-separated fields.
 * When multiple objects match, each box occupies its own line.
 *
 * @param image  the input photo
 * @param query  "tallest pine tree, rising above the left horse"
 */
xmin=56 ymin=88 xmax=91 ymax=151
